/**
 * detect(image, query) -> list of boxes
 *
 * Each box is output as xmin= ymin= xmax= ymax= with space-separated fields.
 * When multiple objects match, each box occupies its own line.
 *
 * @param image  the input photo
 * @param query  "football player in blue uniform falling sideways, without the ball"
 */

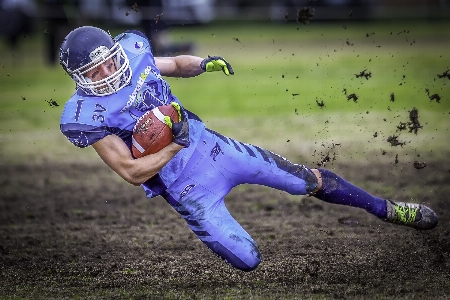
xmin=60 ymin=26 xmax=438 ymax=271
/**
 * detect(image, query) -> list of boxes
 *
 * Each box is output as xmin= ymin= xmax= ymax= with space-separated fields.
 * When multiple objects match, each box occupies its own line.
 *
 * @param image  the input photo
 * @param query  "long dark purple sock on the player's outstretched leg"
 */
xmin=313 ymin=169 xmax=387 ymax=219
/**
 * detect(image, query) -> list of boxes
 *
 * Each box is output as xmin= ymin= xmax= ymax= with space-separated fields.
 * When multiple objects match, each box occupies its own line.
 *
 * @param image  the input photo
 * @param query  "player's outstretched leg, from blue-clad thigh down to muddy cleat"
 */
xmin=206 ymin=128 xmax=438 ymax=229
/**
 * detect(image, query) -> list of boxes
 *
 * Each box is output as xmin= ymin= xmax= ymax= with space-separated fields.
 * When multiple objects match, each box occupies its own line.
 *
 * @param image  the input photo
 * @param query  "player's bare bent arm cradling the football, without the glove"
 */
xmin=92 ymin=134 xmax=183 ymax=185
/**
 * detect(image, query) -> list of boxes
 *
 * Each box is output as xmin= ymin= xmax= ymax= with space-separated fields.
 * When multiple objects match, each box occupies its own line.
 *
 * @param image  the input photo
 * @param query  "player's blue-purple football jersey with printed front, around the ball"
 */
xmin=60 ymin=31 xmax=205 ymax=197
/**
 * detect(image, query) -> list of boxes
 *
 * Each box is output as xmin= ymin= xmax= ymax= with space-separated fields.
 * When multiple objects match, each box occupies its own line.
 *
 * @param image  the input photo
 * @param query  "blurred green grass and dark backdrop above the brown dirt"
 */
xmin=0 ymin=0 xmax=450 ymax=164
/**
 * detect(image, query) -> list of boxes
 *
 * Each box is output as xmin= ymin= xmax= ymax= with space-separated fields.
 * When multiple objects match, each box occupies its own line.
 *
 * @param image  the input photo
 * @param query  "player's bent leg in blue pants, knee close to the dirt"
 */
xmin=162 ymin=142 xmax=261 ymax=271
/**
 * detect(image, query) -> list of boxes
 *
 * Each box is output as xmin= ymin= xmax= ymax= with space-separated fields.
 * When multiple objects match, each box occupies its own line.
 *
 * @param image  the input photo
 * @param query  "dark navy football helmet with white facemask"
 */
xmin=59 ymin=26 xmax=132 ymax=96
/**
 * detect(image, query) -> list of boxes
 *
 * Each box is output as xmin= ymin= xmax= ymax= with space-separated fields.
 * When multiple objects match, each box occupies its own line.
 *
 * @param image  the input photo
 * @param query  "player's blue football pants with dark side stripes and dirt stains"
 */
xmin=162 ymin=129 xmax=317 ymax=271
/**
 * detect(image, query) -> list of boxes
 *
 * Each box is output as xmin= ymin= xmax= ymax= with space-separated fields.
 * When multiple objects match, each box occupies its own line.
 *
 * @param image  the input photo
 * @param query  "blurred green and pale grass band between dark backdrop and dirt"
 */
xmin=0 ymin=21 xmax=450 ymax=161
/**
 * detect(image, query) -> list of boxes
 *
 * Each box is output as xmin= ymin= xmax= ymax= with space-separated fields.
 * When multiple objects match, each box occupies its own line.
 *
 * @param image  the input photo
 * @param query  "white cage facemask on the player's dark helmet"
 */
xmin=69 ymin=43 xmax=132 ymax=96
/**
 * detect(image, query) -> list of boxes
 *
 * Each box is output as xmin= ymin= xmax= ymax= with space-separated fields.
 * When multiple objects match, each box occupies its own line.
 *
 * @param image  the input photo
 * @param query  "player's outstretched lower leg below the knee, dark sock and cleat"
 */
xmin=313 ymin=169 xmax=438 ymax=229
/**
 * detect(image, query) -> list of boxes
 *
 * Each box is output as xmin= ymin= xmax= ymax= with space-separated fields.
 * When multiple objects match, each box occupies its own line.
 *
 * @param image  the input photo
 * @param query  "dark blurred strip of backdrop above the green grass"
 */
xmin=0 ymin=0 xmax=450 ymax=64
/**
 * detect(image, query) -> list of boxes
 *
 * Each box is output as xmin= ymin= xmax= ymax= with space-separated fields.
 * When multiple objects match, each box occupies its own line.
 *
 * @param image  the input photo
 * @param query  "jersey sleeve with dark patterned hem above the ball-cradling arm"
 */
xmin=60 ymin=100 xmax=113 ymax=148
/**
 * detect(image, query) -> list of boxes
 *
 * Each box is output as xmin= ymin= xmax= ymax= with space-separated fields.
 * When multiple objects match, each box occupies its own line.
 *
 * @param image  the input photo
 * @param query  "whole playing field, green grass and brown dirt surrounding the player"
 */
xmin=0 ymin=20 xmax=450 ymax=299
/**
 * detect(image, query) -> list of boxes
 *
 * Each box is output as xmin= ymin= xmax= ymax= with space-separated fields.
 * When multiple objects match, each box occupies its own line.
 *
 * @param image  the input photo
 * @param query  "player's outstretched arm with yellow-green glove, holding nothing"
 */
xmin=155 ymin=55 xmax=234 ymax=78
